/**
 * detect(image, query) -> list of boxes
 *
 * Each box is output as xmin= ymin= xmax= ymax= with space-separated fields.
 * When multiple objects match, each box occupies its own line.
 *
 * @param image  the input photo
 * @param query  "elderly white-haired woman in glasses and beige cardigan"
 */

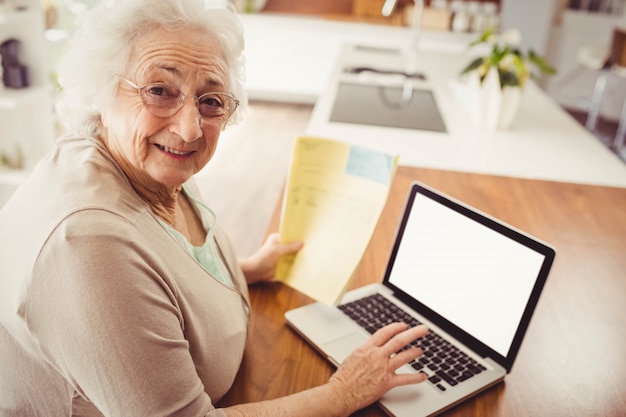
xmin=0 ymin=0 xmax=426 ymax=417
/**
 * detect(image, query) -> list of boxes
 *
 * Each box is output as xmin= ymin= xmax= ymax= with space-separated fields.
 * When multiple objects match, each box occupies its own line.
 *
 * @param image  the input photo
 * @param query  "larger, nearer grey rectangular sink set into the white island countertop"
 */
xmin=330 ymin=81 xmax=446 ymax=132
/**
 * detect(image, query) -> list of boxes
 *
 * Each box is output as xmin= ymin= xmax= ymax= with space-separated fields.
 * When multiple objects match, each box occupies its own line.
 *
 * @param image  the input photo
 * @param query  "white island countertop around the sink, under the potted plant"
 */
xmin=307 ymin=45 xmax=626 ymax=187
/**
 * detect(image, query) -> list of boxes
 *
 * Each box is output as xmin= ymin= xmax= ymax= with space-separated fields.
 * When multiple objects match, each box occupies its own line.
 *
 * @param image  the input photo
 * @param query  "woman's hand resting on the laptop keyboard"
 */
xmin=329 ymin=323 xmax=428 ymax=414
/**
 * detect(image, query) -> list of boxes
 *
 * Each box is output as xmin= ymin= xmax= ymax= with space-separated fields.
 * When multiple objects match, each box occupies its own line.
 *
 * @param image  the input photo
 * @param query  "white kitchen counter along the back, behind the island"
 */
xmin=239 ymin=13 xmax=476 ymax=104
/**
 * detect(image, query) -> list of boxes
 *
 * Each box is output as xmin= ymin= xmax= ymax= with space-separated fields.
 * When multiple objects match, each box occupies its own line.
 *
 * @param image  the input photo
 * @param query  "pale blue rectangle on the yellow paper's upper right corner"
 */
xmin=346 ymin=146 xmax=395 ymax=184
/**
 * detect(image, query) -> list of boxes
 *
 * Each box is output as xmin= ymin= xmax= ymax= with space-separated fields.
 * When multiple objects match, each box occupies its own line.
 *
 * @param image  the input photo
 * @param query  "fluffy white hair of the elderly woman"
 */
xmin=58 ymin=0 xmax=247 ymax=136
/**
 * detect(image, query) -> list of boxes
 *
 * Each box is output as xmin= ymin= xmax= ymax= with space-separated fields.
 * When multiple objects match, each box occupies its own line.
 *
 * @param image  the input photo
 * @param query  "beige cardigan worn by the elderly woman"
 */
xmin=0 ymin=137 xmax=248 ymax=417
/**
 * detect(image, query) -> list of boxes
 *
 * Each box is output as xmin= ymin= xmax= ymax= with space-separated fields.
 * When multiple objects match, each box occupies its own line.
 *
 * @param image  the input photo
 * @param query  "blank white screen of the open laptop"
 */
xmin=389 ymin=194 xmax=544 ymax=356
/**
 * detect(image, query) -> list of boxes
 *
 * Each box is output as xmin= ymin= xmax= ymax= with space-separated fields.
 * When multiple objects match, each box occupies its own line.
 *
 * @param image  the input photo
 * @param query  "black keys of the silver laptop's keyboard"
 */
xmin=338 ymin=294 xmax=487 ymax=391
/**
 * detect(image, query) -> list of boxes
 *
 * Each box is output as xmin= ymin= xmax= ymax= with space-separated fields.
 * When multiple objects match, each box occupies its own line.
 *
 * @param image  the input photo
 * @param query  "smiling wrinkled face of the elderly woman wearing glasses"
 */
xmin=102 ymin=29 xmax=228 ymax=193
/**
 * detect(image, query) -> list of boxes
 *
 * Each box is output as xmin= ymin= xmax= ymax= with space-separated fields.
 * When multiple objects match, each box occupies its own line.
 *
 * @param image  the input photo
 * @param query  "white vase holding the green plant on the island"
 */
xmin=467 ymin=68 xmax=523 ymax=131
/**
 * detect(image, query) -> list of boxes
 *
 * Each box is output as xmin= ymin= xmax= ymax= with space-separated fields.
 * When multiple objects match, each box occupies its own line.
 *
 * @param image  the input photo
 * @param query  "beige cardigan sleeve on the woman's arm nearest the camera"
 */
xmin=20 ymin=210 xmax=225 ymax=417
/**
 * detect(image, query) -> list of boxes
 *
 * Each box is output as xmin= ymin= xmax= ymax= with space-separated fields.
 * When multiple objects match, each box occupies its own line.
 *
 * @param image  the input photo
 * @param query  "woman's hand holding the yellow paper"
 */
xmin=239 ymin=233 xmax=303 ymax=284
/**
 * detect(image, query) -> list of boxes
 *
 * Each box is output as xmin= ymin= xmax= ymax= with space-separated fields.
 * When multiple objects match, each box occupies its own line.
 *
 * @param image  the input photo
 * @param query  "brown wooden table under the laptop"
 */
xmin=218 ymin=167 xmax=626 ymax=417
